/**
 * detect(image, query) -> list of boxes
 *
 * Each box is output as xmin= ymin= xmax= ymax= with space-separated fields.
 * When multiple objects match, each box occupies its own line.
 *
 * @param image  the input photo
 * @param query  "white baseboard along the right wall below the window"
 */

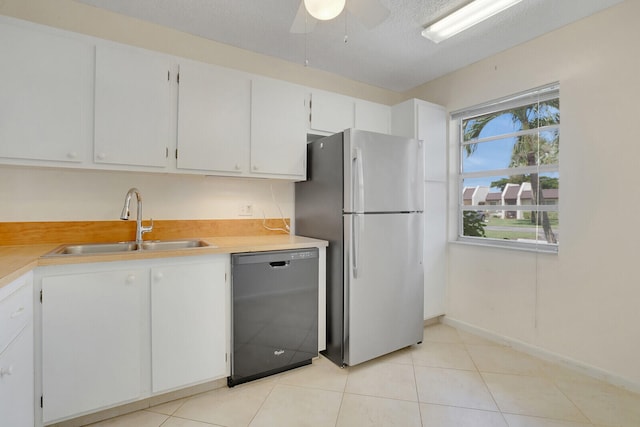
xmin=440 ymin=316 xmax=640 ymax=393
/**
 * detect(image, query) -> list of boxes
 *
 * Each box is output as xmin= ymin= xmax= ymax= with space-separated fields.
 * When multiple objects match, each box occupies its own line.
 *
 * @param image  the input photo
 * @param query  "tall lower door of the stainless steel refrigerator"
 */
xmin=344 ymin=213 xmax=424 ymax=366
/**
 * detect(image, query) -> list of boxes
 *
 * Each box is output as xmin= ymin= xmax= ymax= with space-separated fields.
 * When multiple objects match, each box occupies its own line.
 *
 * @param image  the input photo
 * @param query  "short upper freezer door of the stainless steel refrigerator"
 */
xmin=343 ymin=129 xmax=424 ymax=213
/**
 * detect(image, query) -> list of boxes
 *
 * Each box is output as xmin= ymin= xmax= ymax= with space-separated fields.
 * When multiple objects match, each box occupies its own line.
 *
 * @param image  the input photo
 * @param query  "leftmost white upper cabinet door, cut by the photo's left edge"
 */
xmin=0 ymin=22 xmax=92 ymax=162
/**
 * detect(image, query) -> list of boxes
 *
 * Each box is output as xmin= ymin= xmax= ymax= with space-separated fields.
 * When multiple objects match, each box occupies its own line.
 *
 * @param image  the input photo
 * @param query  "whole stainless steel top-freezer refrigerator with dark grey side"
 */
xmin=295 ymin=129 xmax=424 ymax=365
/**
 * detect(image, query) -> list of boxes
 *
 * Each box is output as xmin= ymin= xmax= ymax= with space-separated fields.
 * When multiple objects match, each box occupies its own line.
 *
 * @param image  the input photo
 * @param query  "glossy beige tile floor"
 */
xmin=86 ymin=324 xmax=640 ymax=427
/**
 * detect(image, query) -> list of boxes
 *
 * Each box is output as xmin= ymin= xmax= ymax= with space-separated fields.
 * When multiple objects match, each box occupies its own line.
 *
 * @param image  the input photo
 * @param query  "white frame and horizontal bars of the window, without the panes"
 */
xmin=450 ymin=82 xmax=561 ymax=254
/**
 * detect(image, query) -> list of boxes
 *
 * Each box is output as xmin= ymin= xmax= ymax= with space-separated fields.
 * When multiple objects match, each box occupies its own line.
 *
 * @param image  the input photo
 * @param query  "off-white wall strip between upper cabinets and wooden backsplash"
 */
xmin=0 ymin=166 xmax=293 ymax=222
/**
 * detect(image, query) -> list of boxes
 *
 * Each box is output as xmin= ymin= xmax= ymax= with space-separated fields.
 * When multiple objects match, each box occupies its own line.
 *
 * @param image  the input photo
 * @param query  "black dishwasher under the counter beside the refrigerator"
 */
xmin=227 ymin=248 xmax=318 ymax=387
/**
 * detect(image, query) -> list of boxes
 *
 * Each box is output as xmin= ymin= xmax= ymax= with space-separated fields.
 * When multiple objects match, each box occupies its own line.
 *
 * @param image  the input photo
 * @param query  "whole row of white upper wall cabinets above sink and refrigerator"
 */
xmin=0 ymin=16 xmax=398 ymax=180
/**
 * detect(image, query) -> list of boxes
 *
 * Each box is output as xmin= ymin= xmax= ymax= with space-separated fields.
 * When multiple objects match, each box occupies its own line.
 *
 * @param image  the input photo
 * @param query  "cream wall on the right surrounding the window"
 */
xmin=407 ymin=0 xmax=640 ymax=390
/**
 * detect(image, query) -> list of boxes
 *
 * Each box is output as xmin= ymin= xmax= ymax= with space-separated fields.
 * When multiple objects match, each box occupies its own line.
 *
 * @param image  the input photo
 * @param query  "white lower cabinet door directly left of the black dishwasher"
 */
xmin=151 ymin=255 xmax=228 ymax=393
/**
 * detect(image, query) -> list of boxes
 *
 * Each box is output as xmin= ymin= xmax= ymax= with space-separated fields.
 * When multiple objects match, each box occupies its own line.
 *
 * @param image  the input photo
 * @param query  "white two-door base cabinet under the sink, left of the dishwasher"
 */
xmin=36 ymin=254 xmax=229 ymax=425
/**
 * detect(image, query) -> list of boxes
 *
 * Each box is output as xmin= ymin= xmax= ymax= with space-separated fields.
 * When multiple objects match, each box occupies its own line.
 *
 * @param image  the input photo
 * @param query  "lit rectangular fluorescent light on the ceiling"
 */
xmin=422 ymin=0 xmax=522 ymax=43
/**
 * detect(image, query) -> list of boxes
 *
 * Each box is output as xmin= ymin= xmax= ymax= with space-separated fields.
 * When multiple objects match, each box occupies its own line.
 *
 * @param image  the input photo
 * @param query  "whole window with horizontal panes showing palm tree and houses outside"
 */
xmin=451 ymin=84 xmax=560 ymax=251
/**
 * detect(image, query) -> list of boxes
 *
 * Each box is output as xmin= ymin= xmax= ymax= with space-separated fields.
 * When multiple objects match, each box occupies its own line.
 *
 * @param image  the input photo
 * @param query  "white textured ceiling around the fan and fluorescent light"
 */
xmin=77 ymin=0 xmax=622 ymax=92
